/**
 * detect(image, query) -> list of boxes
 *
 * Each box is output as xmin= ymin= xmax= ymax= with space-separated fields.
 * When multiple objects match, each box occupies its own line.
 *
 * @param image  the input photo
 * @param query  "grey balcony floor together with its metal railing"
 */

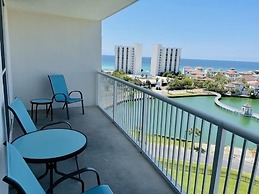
xmin=8 ymin=73 xmax=259 ymax=194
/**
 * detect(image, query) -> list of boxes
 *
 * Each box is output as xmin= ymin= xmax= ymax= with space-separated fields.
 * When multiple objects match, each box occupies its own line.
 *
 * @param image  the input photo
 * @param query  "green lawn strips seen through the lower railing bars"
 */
xmin=132 ymin=133 xmax=259 ymax=193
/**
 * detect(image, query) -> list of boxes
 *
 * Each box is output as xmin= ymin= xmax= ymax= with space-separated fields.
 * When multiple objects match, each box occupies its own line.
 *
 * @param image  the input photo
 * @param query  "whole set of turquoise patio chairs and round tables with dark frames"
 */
xmin=3 ymin=75 xmax=113 ymax=194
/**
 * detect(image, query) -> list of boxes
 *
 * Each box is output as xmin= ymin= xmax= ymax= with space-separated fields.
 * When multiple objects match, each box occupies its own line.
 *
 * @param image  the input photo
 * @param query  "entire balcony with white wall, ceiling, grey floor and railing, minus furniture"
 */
xmin=3 ymin=0 xmax=259 ymax=193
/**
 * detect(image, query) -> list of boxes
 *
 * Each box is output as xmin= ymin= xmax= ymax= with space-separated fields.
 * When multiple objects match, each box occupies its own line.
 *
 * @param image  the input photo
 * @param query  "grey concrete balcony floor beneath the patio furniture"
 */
xmin=10 ymin=107 xmax=177 ymax=194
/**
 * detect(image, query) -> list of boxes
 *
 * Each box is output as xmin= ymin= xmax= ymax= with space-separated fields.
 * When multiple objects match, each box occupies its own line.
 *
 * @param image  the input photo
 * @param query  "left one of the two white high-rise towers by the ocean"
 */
xmin=114 ymin=44 xmax=142 ymax=74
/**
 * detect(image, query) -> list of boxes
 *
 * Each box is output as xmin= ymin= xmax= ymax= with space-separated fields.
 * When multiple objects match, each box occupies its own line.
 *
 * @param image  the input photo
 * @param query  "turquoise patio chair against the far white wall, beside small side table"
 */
xmin=48 ymin=75 xmax=84 ymax=119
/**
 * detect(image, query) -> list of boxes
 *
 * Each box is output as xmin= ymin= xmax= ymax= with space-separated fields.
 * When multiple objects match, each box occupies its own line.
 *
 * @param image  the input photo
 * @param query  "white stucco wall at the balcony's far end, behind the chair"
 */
xmin=8 ymin=9 xmax=101 ymax=109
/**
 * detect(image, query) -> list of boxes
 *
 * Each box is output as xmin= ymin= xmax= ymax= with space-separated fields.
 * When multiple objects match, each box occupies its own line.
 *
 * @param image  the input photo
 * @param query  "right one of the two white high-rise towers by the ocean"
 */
xmin=150 ymin=44 xmax=181 ymax=75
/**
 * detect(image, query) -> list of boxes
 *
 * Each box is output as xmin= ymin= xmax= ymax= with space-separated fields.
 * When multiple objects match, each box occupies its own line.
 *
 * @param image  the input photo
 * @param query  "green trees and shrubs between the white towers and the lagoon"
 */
xmin=111 ymin=70 xmax=256 ymax=98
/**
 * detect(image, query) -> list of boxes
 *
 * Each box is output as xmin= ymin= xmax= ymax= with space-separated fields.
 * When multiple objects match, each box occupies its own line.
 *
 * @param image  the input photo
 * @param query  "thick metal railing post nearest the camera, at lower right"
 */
xmin=209 ymin=126 xmax=226 ymax=194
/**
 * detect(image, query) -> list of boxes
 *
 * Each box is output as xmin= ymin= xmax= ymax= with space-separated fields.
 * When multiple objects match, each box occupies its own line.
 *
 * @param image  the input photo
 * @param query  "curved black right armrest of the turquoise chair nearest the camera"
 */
xmin=46 ymin=167 xmax=101 ymax=194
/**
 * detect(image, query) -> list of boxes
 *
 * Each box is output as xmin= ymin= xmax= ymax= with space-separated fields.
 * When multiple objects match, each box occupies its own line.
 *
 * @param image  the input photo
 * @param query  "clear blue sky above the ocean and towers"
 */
xmin=102 ymin=0 xmax=259 ymax=62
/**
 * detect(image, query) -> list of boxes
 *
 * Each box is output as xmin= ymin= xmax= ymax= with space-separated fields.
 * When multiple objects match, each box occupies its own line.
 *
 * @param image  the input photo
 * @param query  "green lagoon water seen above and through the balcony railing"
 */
xmin=114 ymin=96 xmax=259 ymax=148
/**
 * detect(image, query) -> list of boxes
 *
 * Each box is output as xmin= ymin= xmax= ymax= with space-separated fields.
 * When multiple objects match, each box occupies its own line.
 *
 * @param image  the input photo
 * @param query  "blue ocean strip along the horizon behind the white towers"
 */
xmin=102 ymin=55 xmax=259 ymax=72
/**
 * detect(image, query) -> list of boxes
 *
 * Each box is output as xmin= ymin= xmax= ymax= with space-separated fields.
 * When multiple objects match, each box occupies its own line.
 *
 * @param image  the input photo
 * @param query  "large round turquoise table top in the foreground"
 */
xmin=12 ymin=129 xmax=87 ymax=163
